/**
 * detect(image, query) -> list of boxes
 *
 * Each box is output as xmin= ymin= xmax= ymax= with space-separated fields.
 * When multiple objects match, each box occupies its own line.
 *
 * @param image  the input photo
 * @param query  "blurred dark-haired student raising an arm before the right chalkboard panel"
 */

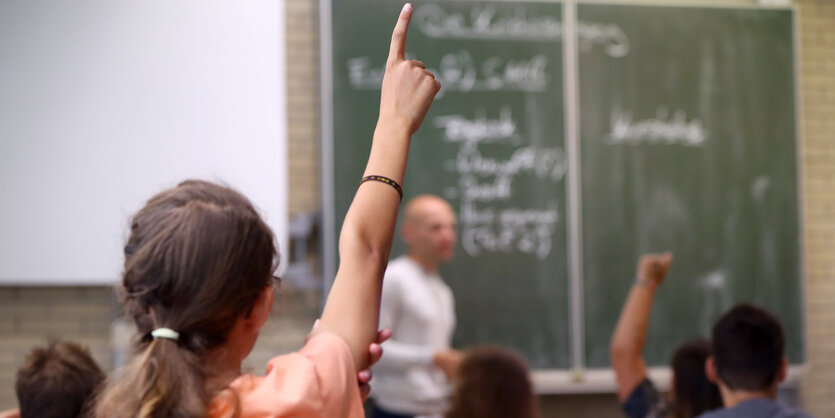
xmin=611 ymin=252 xmax=722 ymax=418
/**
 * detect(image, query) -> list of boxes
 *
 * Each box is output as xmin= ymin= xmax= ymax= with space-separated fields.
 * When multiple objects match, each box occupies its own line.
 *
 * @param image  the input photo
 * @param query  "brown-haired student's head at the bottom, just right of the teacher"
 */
xmin=446 ymin=347 xmax=539 ymax=418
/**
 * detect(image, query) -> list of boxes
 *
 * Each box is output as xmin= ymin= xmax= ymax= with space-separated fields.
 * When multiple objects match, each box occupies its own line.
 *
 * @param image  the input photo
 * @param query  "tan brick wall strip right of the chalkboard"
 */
xmin=799 ymin=0 xmax=835 ymax=417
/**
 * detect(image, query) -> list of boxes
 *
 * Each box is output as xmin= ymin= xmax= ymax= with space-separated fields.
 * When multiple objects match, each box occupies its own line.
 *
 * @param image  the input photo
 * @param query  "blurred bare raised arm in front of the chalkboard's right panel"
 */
xmin=610 ymin=252 xmax=673 ymax=403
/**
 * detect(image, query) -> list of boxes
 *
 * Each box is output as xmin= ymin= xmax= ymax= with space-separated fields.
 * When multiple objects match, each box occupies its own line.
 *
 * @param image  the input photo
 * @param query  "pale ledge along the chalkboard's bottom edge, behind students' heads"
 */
xmin=533 ymin=364 xmax=808 ymax=395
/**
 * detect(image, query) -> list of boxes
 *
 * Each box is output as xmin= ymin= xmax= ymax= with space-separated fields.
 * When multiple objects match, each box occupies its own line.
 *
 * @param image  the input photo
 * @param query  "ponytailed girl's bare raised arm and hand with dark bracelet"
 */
xmin=315 ymin=4 xmax=440 ymax=370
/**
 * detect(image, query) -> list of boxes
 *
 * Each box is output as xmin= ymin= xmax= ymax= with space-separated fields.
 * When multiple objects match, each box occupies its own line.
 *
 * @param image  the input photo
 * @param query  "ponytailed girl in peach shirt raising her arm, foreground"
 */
xmin=96 ymin=4 xmax=440 ymax=418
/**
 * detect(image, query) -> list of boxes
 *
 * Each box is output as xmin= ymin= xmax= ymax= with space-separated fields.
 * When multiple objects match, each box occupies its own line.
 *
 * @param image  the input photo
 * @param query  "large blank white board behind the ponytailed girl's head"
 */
xmin=0 ymin=0 xmax=287 ymax=285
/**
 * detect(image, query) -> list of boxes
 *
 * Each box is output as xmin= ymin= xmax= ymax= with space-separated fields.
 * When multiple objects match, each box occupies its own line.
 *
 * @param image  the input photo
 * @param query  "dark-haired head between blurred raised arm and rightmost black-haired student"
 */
xmin=672 ymin=338 xmax=722 ymax=418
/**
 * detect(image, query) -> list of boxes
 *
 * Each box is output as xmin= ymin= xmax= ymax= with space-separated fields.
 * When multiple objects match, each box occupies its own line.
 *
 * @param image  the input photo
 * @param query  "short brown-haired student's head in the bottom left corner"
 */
xmin=15 ymin=341 xmax=104 ymax=418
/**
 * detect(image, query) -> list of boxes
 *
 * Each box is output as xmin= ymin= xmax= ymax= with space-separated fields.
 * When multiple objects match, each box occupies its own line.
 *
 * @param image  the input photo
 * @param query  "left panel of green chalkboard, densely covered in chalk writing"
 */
xmin=330 ymin=0 xmax=569 ymax=368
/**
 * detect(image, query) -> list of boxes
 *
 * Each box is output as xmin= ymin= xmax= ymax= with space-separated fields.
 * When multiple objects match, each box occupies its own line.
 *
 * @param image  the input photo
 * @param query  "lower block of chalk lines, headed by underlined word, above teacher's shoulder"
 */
xmin=432 ymin=106 xmax=568 ymax=259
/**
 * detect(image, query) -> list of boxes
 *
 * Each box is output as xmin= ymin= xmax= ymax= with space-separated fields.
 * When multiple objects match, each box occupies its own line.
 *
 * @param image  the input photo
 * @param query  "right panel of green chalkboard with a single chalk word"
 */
xmin=578 ymin=4 xmax=803 ymax=367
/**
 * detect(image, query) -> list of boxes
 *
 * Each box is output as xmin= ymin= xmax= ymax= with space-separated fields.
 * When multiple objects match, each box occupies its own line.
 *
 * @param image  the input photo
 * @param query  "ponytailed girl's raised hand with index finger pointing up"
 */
xmin=379 ymin=3 xmax=441 ymax=135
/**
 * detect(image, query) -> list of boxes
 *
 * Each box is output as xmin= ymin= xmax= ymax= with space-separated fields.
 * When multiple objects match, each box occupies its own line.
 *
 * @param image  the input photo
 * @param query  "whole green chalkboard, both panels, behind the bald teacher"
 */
xmin=323 ymin=0 xmax=803 ymax=369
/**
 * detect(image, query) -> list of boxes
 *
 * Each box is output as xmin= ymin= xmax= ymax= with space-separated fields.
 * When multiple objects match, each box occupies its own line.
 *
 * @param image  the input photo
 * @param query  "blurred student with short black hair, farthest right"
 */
xmin=701 ymin=304 xmax=809 ymax=418
